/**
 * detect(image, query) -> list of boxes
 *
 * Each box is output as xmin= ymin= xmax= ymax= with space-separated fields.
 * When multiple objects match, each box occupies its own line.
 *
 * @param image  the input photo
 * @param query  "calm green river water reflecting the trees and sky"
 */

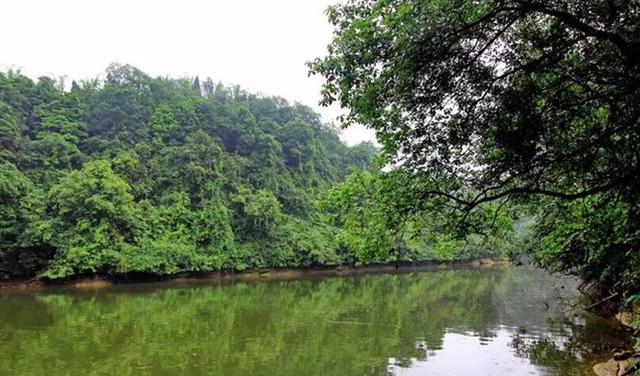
xmin=0 ymin=266 xmax=622 ymax=376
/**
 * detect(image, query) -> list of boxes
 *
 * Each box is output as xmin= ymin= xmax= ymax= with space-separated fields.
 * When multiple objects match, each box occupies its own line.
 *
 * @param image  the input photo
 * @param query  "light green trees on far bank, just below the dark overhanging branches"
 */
xmin=323 ymin=169 xmax=526 ymax=263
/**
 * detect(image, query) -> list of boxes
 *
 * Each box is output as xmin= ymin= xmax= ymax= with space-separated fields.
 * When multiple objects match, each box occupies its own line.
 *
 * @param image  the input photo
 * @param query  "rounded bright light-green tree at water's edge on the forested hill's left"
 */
xmin=42 ymin=160 xmax=138 ymax=278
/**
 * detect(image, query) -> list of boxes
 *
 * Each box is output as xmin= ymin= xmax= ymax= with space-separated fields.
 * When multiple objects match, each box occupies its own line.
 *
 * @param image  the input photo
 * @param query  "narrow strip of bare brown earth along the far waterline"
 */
xmin=0 ymin=257 xmax=511 ymax=291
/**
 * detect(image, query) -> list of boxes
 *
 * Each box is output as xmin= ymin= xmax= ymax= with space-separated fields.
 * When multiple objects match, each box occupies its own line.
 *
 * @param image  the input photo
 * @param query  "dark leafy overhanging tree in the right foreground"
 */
xmin=310 ymin=0 xmax=640 ymax=296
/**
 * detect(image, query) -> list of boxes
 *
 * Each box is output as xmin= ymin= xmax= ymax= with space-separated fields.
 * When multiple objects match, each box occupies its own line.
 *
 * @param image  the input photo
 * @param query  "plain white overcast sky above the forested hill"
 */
xmin=0 ymin=0 xmax=375 ymax=145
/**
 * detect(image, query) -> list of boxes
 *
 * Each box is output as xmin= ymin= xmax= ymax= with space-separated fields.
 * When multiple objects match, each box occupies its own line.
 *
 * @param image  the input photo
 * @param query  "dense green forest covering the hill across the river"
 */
xmin=0 ymin=64 xmax=515 ymax=279
